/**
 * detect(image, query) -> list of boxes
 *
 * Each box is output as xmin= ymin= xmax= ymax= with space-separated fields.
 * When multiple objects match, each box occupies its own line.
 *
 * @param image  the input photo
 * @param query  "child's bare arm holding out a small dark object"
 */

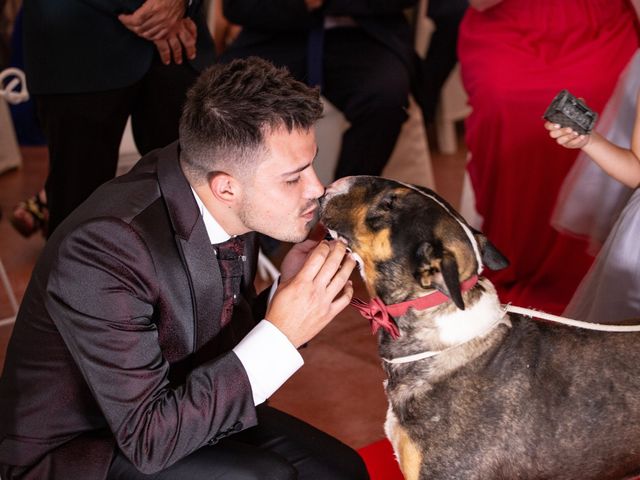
xmin=544 ymin=91 xmax=640 ymax=188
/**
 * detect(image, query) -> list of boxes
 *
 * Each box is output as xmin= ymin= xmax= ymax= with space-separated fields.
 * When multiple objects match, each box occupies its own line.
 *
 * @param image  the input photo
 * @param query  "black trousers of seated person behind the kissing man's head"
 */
xmin=221 ymin=28 xmax=411 ymax=182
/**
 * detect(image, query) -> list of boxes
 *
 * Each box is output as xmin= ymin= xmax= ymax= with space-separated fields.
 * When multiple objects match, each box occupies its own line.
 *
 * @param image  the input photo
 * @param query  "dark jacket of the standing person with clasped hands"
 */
xmin=23 ymin=0 xmax=215 ymax=94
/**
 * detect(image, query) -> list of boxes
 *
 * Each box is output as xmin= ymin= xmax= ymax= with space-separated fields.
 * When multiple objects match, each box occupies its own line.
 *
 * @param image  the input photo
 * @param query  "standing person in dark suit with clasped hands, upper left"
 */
xmin=23 ymin=0 xmax=215 ymax=234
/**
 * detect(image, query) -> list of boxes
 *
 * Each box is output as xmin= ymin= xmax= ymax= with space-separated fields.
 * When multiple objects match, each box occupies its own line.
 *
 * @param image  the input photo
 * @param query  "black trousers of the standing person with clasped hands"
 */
xmin=34 ymin=59 xmax=198 ymax=235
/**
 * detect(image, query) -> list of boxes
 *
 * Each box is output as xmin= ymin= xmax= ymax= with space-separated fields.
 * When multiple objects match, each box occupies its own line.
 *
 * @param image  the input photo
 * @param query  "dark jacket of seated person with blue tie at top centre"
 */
xmin=224 ymin=0 xmax=416 ymax=71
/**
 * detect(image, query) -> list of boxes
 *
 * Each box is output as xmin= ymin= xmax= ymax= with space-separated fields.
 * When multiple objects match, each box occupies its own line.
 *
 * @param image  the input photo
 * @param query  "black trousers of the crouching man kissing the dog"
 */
xmin=107 ymin=405 xmax=369 ymax=480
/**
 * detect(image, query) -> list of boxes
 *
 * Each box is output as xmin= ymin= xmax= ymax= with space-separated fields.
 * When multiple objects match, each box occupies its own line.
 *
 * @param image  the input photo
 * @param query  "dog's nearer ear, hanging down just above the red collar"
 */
xmin=417 ymin=242 xmax=464 ymax=310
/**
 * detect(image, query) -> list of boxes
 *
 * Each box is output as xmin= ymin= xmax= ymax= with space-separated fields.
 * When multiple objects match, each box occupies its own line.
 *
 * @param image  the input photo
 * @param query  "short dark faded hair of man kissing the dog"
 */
xmin=180 ymin=57 xmax=322 ymax=183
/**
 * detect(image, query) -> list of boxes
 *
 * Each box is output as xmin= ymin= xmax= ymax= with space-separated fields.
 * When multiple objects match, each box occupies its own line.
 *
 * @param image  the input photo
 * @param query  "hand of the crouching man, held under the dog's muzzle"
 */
xmin=265 ymin=240 xmax=356 ymax=348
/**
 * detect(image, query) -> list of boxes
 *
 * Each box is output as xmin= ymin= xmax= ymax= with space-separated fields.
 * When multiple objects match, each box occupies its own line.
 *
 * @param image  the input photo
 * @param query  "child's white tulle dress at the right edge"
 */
xmin=554 ymin=51 xmax=640 ymax=323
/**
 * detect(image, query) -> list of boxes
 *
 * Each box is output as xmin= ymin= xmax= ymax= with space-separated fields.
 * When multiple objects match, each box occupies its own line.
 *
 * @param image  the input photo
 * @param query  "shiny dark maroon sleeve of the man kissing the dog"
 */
xmin=47 ymin=219 xmax=256 ymax=473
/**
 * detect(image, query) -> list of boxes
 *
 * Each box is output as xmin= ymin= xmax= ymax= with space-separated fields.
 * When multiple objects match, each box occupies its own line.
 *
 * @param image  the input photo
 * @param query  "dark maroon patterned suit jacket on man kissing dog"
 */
xmin=0 ymin=144 xmax=266 ymax=480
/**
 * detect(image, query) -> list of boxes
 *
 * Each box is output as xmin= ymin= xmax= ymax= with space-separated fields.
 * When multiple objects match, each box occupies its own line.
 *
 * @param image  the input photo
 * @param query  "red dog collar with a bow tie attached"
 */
xmin=351 ymin=275 xmax=478 ymax=340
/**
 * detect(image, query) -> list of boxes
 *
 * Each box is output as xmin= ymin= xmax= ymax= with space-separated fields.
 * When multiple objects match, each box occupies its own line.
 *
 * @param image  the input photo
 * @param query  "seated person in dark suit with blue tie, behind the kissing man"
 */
xmin=221 ymin=0 xmax=417 ymax=178
